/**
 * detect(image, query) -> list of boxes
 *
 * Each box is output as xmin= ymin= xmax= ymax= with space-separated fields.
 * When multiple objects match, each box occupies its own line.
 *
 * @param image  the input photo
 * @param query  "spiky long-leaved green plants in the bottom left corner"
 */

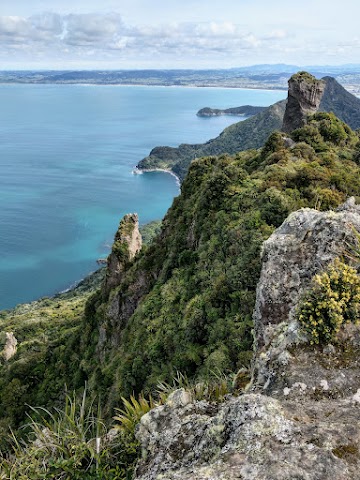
xmin=0 ymin=391 xmax=131 ymax=480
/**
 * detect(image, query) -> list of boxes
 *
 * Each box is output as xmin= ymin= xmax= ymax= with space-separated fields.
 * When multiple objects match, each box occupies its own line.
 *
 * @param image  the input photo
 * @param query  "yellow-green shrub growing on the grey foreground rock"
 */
xmin=298 ymin=259 xmax=360 ymax=344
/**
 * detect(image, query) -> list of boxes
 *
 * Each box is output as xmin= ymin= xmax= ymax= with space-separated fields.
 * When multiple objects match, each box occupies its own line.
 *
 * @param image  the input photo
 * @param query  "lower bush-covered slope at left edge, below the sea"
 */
xmin=0 ymin=269 xmax=105 ymax=447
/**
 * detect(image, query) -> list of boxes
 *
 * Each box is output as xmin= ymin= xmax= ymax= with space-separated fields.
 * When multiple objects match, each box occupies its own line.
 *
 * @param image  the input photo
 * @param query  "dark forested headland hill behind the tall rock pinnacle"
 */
xmin=137 ymin=77 xmax=360 ymax=181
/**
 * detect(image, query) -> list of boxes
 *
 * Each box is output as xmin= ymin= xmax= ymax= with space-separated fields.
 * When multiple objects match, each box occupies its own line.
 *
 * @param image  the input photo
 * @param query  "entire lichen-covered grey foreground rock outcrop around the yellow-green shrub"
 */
xmin=136 ymin=199 xmax=360 ymax=480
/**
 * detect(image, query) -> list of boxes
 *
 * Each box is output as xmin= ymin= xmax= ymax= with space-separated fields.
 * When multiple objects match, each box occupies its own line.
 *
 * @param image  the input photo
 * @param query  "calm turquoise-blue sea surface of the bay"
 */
xmin=0 ymin=85 xmax=286 ymax=310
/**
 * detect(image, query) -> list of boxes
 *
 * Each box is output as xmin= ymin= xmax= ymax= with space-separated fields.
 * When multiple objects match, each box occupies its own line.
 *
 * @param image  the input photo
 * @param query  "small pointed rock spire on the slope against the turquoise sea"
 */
xmin=103 ymin=213 xmax=142 ymax=295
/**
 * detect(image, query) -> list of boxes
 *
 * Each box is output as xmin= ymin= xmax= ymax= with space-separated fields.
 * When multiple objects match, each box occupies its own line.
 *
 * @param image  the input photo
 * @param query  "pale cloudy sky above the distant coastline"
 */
xmin=0 ymin=0 xmax=360 ymax=70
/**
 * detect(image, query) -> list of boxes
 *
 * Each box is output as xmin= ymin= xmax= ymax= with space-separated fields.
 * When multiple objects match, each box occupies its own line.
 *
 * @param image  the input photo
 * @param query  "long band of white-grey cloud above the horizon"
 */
xmin=0 ymin=8 xmax=360 ymax=68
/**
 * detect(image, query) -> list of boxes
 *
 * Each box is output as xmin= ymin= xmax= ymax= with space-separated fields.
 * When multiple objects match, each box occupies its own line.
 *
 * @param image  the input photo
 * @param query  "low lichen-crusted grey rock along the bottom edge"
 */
xmin=136 ymin=391 xmax=359 ymax=480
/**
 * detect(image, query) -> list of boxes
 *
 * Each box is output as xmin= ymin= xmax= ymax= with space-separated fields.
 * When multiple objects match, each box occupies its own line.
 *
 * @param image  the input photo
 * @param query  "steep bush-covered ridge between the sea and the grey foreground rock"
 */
xmin=87 ymin=113 xmax=360 ymax=405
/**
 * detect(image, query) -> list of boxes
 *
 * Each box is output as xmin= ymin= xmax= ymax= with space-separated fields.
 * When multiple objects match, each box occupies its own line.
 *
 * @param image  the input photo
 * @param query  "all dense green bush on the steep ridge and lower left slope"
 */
xmin=0 ymin=113 xmax=360 ymax=478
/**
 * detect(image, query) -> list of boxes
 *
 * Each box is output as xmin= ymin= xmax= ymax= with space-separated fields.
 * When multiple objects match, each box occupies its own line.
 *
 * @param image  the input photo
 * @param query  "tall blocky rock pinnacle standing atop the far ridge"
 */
xmin=282 ymin=72 xmax=325 ymax=133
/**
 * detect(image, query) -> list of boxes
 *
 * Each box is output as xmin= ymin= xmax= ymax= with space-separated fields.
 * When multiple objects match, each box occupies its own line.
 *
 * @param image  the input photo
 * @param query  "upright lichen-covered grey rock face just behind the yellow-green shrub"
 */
xmin=254 ymin=199 xmax=360 ymax=346
